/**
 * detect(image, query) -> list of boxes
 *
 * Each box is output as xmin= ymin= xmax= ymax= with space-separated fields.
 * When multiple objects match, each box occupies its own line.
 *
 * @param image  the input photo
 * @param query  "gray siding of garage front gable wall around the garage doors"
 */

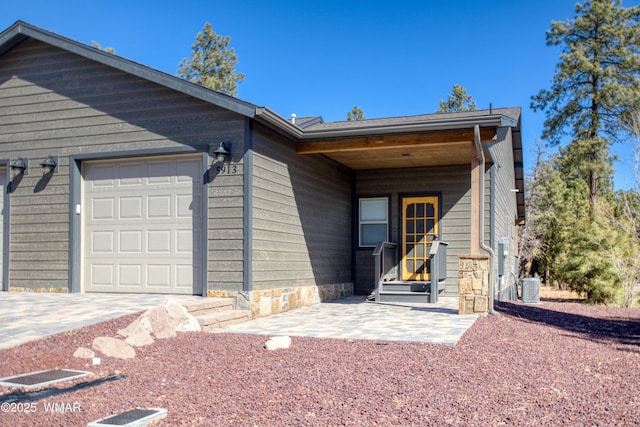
xmin=0 ymin=40 xmax=245 ymax=290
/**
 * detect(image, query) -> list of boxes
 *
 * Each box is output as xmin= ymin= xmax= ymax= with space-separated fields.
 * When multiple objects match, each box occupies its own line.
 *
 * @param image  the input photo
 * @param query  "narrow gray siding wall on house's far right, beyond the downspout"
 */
xmin=486 ymin=128 xmax=517 ymax=298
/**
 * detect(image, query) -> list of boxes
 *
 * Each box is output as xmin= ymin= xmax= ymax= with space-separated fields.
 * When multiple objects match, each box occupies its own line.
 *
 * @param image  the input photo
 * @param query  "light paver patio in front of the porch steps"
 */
xmin=213 ymin=296 xmax=478 ymax=345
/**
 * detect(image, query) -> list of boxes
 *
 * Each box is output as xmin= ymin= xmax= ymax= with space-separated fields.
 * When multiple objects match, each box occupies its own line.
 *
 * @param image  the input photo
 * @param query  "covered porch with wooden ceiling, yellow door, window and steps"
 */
xmin=296 ymin=110 xmax=523 ymax=310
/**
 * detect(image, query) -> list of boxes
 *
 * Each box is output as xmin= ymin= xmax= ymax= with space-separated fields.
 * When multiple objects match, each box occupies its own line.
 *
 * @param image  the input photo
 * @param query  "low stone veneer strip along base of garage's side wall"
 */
xmin=207 ymin=283 xmax=353 ymax=319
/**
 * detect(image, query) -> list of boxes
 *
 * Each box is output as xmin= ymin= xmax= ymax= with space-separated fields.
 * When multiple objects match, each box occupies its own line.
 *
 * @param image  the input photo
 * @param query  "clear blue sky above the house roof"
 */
xmin=0 ymin=0 xmax=633 ymax=187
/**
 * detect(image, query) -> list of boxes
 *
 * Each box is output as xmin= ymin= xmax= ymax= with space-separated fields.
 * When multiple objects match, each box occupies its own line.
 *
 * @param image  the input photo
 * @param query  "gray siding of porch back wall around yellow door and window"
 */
xmin=355 ymin=166 xmax=471 ymax=295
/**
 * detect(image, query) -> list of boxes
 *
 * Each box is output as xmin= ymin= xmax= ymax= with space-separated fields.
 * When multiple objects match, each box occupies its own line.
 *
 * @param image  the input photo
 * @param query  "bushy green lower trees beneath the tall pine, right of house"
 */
xmin=523 ymin=130 xmax=640 ymax=306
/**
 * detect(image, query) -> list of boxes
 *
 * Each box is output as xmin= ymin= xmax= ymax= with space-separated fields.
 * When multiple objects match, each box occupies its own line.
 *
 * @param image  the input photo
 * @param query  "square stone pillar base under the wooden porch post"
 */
xmin=458 ymin=255 xmax=489 ymax=314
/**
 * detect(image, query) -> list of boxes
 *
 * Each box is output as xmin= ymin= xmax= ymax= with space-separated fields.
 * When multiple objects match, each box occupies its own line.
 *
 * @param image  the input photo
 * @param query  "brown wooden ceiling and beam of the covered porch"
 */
xmin=296 ymin=128 xmax=497 ymax=170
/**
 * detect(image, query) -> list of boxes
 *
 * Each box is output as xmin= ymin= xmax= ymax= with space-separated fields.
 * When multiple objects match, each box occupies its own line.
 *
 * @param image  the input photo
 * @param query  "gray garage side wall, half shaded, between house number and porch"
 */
xmin=252 ymin=125 xmax=352 ymax=290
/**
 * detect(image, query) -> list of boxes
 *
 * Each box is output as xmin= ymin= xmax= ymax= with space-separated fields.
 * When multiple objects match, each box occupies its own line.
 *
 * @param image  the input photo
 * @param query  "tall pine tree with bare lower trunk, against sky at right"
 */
xmin=531 ymin=0 xmax=640 ymax=205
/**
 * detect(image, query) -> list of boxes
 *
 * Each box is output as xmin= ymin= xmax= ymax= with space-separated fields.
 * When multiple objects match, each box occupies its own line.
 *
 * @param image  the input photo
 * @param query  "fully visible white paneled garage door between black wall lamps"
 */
xmin=81 ymin=156 xmax=203 ymax=294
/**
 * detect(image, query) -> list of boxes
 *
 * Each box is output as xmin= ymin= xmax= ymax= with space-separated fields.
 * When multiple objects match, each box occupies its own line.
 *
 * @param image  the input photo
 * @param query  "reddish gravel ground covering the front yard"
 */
xmin=0 ymin=302 xmax=640 ymax=426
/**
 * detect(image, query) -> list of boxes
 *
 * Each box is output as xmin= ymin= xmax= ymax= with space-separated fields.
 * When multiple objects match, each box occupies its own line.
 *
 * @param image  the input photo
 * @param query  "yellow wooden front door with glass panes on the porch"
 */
xmin=401 ymin=196 xmax=438 ymax=281
